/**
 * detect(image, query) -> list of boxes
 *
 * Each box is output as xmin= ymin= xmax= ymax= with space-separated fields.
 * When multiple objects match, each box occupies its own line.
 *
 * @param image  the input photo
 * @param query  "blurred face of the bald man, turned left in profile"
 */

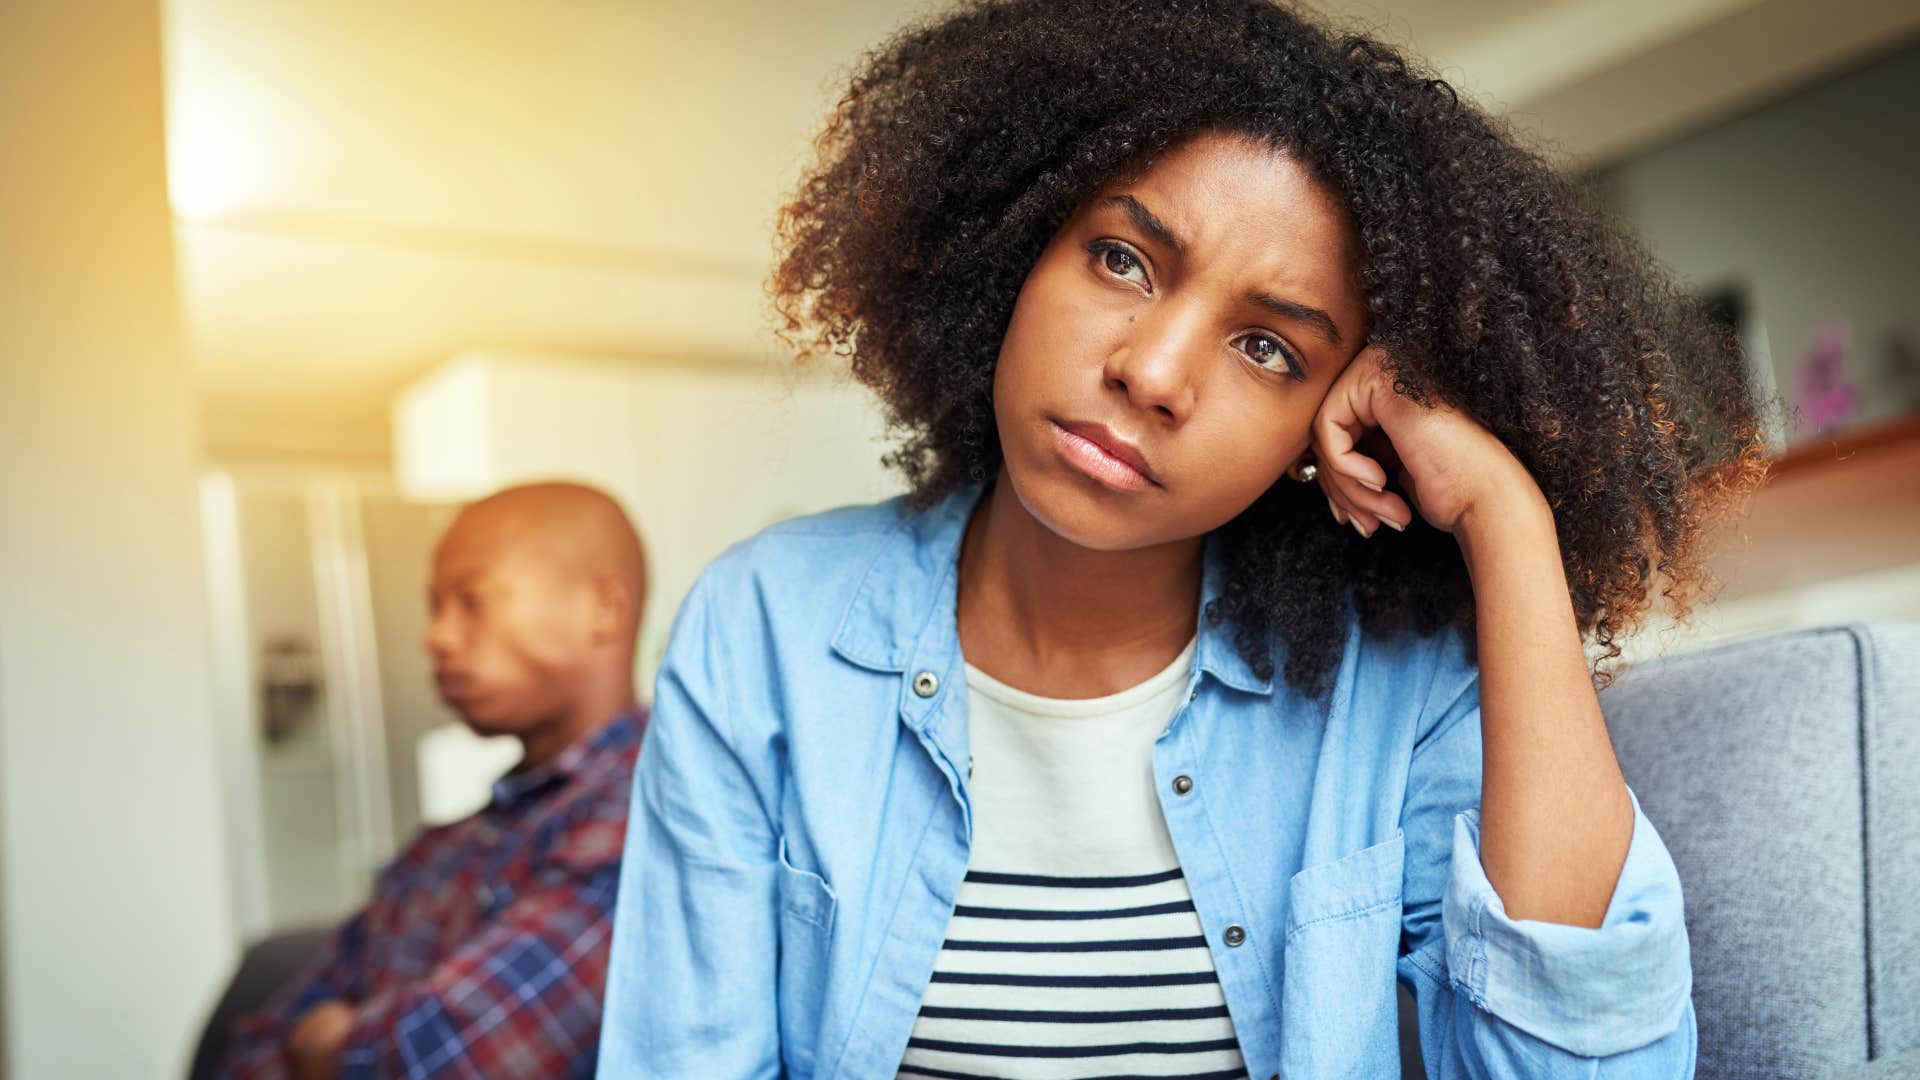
xmin=424 ymin=515 xmax=593 ymax=734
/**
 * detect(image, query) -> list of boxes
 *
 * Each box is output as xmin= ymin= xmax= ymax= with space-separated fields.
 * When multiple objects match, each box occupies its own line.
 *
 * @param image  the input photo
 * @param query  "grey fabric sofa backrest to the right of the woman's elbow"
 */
xmin=1601 ymin=623 xmax=1920 ymax=1080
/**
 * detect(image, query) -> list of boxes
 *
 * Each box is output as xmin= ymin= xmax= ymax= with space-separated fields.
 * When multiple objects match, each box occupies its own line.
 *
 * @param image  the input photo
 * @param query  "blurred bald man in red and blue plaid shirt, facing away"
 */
xmin=227 ymin=484 xmax=647 ymax=1080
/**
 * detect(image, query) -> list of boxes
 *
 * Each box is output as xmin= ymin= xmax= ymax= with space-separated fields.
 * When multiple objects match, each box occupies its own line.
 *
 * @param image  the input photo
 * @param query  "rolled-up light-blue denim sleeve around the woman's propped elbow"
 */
xmin=1400 ymin=634 xmax=1697 ymax=1080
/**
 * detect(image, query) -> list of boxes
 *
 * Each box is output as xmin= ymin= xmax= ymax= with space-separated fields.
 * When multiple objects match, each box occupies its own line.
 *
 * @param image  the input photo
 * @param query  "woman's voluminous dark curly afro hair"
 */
xmin=770 ymin=0 xmax=1766 ymax=696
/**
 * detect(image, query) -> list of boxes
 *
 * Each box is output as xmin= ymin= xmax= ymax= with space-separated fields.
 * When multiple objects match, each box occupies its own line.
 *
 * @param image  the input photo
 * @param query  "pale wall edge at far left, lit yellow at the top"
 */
xmin=0 ymin=0 xmax=234 ymax=1080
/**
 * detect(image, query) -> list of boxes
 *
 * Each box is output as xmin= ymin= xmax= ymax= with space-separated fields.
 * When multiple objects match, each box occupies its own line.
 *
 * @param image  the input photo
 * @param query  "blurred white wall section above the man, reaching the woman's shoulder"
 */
xmin=394 ymin=352 xmax=902 ymax=676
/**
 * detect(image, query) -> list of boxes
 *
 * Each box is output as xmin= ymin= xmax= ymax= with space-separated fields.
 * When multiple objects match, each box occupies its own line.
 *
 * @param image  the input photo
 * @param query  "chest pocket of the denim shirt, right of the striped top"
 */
xmin=1281 ymin=828 xmax=1405 ymax=1076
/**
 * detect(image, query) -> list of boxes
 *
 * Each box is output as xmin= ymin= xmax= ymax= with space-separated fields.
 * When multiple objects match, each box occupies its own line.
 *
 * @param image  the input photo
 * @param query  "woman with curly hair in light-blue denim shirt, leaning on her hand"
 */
xmin=601 ymin=0 xmax=1763 ymax=1076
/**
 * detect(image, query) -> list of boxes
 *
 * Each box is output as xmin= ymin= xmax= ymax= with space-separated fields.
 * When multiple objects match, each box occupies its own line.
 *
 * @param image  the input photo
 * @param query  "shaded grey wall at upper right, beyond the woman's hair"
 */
xmin=1596 ymin=38 xmax=1920 ymax=432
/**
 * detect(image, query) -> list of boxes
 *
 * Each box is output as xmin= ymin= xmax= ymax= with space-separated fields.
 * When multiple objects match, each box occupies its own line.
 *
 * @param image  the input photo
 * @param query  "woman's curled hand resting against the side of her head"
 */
xmin=1311 ymin=346 xmax=1546 ymax=540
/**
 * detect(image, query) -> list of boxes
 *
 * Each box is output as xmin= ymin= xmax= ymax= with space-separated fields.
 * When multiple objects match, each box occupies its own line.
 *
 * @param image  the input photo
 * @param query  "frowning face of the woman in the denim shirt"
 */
xmin=993 ymin=133 xmax=1367 ymax=552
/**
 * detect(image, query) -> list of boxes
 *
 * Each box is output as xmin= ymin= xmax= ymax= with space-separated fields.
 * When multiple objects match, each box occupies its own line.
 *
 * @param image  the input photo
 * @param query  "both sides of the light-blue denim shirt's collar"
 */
xmin=833 ymin=484 xmax=1273 ymax=699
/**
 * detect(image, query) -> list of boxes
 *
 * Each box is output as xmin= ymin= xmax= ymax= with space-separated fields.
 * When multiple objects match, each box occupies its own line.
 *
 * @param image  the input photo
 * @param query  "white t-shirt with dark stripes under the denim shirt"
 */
xmin=900 ymin=644 xmax=1246 ymax=1080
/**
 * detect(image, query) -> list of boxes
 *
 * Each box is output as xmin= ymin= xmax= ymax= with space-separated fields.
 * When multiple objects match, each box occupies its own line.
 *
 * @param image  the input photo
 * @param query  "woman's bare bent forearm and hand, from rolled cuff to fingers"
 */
xmin=1313 ymin=346 xmax=1634 ymax=928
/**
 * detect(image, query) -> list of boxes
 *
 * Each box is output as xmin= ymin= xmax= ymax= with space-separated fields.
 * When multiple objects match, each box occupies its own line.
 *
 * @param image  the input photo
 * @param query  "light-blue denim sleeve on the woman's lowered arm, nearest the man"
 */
xmin=597 ymin=569 xmax=780 ymax=1080
